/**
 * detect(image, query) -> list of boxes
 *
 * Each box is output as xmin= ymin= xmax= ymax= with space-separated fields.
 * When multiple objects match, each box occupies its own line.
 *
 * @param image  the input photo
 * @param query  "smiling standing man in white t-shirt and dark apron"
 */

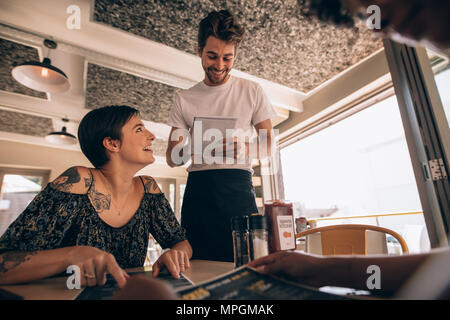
xmin=166 ymin=10 xmax=275 ymax=261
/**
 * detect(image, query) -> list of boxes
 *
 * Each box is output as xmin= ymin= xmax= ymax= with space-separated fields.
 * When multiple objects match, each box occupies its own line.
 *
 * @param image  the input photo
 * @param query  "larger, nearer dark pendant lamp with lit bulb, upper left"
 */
xmin=11 ymin=39 xmax=70 ymax=93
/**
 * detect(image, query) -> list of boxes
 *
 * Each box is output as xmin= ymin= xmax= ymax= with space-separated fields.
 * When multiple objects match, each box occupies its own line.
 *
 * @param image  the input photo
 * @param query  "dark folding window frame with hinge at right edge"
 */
xmin=383 ymin=39 xmax=450 ymax=248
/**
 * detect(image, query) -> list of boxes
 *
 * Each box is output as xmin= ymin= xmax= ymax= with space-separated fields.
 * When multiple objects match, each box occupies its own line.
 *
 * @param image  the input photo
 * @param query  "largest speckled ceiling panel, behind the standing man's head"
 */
xmin=93 ymin=0 xmax=382 ymax=92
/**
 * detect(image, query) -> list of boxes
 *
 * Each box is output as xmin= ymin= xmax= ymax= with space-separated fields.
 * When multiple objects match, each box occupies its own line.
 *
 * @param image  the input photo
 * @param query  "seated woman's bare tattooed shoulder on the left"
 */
xmin=50 ymin=166 xmax=94 ymax=194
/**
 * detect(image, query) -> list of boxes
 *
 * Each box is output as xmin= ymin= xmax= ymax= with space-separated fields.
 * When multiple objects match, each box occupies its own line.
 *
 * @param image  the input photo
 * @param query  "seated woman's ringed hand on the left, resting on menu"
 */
xmin=67 ymin=246 xmax=130 ymax=288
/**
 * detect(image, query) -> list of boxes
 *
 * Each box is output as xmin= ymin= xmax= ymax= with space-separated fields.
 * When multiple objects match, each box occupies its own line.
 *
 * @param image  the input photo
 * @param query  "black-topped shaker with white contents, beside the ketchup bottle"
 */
xmin=250 ymin=213 xmax=269 ymax=260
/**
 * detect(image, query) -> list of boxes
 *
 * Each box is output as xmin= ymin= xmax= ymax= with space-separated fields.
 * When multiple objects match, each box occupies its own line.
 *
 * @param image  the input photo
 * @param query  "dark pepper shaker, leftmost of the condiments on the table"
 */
xmin=231 ymin=216 xmax=250 ymax=268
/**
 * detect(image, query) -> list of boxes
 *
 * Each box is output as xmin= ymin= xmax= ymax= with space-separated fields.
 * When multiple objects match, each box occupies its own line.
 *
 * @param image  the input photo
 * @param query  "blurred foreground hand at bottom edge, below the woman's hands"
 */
xmin=113 ymin=275 xmax=179 ymax=300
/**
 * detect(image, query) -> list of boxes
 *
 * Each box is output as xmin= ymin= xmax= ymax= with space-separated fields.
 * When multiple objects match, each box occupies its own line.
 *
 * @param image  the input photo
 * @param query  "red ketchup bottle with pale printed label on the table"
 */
xmin=264 ymin=200 xmax=295 ymax=253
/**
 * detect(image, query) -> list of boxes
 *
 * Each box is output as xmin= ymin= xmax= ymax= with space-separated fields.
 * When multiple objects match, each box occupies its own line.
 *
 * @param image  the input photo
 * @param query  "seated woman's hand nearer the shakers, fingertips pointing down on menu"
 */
xmin=153 ymin=249 xmax=191 ymax=279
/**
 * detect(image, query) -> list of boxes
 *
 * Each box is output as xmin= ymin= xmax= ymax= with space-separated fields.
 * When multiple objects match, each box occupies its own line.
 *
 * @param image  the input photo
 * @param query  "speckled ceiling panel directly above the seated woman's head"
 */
xmin=86 ymin=63 xmax=177 ymax=123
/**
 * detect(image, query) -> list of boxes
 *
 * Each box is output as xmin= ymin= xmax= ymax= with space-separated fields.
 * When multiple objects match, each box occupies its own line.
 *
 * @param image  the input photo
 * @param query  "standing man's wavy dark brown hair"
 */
xmin=198 ymin=10 xmax=245 ymax=50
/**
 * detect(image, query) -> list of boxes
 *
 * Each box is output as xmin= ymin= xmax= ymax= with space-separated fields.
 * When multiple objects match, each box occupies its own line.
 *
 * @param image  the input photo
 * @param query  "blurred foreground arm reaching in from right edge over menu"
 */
xmin=248 ymin=248 xmax=449 ymax=294
